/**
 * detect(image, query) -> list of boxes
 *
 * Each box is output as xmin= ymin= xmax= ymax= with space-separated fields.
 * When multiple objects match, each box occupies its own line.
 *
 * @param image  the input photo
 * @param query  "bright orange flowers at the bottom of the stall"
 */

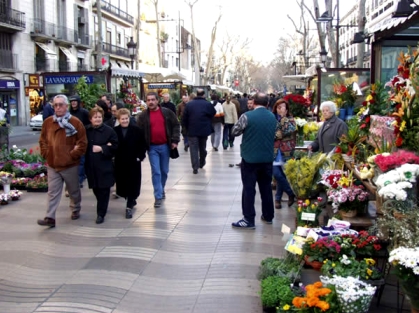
xmin=292 ymin=282 xmax=332 ymax=312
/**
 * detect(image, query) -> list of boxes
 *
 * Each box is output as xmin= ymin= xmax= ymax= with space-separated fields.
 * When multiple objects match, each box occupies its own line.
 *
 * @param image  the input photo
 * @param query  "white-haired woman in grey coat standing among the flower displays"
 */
xmin=308 ymin=101 xmax=348 ymax=153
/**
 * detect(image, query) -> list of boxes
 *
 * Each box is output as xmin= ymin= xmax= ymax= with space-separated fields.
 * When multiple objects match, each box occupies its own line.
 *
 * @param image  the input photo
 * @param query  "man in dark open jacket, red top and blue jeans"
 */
xmin=137 ymin=92 xmax=180 ymax=208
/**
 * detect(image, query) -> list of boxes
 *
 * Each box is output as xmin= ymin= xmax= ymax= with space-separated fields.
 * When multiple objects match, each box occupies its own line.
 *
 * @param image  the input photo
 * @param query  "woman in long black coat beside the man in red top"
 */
xmin=114 ymin=108 xmax=146 ymax=218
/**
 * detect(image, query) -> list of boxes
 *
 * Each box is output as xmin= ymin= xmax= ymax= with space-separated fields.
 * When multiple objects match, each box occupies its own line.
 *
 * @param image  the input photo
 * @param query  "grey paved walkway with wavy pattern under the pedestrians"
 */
xmin=0 ymin=138 xmax=406 ymax=313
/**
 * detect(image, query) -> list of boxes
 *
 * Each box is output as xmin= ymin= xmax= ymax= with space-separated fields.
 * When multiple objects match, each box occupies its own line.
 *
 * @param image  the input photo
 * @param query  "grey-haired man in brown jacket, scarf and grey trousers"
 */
xmin=38 ymin=95 xmax=87 ymax=227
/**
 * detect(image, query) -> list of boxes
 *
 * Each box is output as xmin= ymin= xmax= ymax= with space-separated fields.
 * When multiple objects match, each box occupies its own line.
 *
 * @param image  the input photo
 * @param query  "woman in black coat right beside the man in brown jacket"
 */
xmin=84 ymin=107 xmax=118 ymax=224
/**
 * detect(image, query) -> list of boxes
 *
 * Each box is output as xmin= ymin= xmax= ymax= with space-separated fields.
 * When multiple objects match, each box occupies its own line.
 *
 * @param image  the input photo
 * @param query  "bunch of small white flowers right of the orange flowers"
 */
xmin=320 ymin=276 xmax=377 ymax=313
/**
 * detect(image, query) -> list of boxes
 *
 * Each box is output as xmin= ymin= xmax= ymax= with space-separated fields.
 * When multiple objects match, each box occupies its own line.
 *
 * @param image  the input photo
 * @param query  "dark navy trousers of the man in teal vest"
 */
xmin=240 ymin=159 xmax=274 ymax=224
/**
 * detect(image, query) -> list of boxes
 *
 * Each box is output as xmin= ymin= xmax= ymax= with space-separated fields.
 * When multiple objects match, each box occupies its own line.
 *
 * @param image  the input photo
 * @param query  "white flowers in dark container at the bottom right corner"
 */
xmin=388 ymin=247 xmax=419 ymax=310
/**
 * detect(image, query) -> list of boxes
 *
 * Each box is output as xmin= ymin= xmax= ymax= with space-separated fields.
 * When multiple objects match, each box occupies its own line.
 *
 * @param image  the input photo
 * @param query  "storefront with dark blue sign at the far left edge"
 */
xmin=0 ymin=79 xmax=20 ymax=126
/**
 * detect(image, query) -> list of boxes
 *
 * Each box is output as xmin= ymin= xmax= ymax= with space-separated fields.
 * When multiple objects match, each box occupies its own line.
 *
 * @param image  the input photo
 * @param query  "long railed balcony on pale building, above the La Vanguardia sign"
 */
xmin=31 ymin=19 xmax=91 ymax=48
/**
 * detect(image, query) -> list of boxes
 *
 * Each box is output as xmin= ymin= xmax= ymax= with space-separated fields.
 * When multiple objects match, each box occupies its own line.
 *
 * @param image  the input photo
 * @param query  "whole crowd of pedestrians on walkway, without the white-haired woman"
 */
xmin=38 ymin=89 xmax=306 ymax=228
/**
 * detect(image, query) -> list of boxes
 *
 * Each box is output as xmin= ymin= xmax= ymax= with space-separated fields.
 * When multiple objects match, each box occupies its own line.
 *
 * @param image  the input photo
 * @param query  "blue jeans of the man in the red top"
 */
xmin=148 ymin=144 xmax=170 ymax=200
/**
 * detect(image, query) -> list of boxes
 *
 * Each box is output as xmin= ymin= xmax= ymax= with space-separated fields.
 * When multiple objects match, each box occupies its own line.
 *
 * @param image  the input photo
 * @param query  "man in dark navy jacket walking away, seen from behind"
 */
xmin=182 ymin=89 xmax=217 ymax=174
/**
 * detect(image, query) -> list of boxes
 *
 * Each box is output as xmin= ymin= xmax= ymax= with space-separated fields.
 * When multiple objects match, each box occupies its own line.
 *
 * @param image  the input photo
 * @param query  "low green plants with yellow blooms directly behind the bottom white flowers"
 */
xmin=321 ymin=254 xmax=383 ymax=280
